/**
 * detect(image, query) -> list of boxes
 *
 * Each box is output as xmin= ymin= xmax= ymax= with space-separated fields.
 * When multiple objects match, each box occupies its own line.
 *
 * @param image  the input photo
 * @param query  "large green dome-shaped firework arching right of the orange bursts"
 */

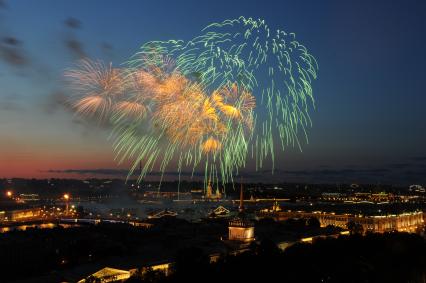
xmin=157 ymin=17 xmax=318 ymax=171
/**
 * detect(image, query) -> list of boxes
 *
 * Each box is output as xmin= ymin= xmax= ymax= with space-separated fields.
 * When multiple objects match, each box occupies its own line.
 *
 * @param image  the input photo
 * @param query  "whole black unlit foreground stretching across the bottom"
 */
xmin=0 ymin=221 xmax=426 ymax=283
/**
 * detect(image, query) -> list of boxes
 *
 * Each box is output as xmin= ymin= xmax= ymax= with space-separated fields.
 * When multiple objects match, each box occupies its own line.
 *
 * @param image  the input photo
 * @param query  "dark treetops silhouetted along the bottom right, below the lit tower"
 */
xmin=131 ymin=233 xmax=426 ymax=283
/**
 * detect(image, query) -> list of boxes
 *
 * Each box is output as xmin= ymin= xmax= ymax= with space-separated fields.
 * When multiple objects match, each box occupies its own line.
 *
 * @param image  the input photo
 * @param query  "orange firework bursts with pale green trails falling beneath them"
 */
xmin=112 ymin=53 xmax=255 ymax=187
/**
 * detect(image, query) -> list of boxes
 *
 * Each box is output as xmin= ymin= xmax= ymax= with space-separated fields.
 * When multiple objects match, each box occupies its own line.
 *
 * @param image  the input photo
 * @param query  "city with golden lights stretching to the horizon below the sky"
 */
xmin=0 ymin=179 xmax=426 ymax=282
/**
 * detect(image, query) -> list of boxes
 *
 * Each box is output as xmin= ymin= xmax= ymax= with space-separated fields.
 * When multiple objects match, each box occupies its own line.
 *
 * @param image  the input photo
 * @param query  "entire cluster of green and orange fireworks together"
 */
xmin=66 ymin=17 xmax=318 ymax=192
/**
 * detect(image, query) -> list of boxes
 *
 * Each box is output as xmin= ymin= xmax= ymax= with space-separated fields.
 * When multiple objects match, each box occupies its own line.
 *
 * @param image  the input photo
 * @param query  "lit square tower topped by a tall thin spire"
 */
xmin=228 ymin=184 xmax=255 ymax=242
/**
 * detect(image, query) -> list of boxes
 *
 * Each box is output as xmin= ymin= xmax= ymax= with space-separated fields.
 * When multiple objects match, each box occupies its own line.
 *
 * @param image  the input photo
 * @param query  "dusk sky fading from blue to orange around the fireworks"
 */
xmin=0 ymin=0 xmax=426 ymax=184
